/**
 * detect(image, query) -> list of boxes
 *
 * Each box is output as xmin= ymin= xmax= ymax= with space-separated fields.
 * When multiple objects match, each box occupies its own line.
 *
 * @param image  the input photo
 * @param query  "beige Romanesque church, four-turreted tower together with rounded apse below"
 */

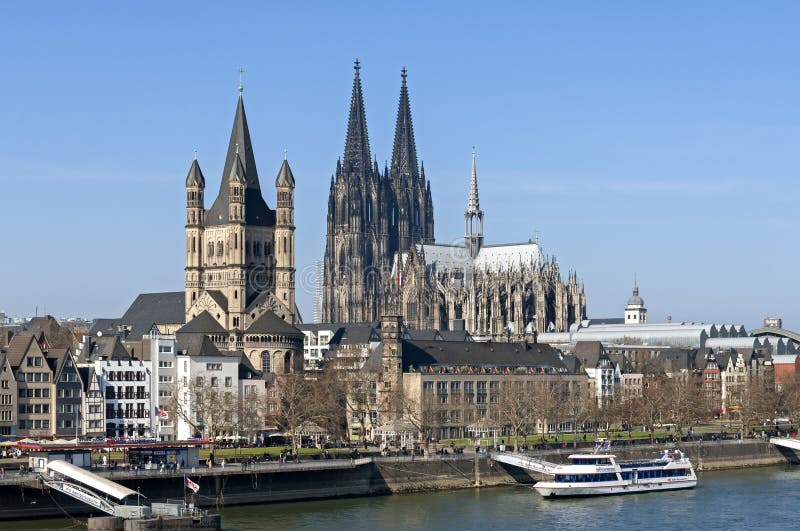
xmin=181 ymin=91 xmax=303 ymax=374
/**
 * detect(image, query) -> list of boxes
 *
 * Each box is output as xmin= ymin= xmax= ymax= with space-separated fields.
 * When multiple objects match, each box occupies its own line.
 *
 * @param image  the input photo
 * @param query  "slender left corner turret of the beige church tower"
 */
xmin=185 ymin=154 xmax=206 ymax=312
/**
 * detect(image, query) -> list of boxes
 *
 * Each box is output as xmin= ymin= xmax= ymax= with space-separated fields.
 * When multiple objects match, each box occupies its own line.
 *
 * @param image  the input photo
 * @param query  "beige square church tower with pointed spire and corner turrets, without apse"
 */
xmin=185 ymin=91 xmax=298 ymax=330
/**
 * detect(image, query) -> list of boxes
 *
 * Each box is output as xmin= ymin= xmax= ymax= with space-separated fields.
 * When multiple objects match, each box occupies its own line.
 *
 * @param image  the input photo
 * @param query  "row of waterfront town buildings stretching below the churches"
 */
xmin=0 ymin=288 xmax=800 ymax=440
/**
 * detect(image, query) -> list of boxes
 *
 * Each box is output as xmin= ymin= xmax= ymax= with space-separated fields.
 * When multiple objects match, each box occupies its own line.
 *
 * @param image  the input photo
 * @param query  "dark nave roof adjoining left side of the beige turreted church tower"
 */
xmin=119 ymin=291 xmax=186 ymax=341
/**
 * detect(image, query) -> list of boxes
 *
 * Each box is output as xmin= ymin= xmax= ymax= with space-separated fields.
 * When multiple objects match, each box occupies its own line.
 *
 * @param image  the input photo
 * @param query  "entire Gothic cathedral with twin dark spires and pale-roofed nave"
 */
xmin=321 ymin=61 xmax=586 ymax=339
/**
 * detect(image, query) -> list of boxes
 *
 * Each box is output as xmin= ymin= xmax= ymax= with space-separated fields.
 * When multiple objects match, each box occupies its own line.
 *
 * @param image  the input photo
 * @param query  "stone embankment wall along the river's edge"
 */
xmin=0 ymin=441 xmax=797 ymax=520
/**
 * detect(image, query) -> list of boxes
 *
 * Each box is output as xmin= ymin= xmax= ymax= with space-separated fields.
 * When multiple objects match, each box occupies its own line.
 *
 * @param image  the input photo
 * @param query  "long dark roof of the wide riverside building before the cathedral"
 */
xmin=402 ymin=341 xmax=567 ymax=372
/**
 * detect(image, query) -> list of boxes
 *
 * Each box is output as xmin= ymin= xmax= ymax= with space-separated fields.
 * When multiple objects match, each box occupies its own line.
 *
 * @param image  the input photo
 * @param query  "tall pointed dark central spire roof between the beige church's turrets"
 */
xmin=205 ymin=96 xmax=275 ymax=227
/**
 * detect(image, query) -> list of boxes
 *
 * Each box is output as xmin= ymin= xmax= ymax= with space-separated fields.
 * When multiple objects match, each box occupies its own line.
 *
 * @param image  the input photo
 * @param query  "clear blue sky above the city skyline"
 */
xmin=0 ymin=1 xmax=800 ymax=329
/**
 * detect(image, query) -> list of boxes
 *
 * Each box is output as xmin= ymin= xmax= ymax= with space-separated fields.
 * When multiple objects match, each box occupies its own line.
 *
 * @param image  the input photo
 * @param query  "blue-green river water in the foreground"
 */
xmin=0 ymin=466 xmax=800 ymax=531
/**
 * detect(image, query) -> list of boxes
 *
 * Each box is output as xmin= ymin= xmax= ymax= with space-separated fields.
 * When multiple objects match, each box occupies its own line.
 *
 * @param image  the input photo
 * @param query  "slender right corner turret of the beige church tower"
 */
xmin=275 ymin=158 xmax=295 ymax=319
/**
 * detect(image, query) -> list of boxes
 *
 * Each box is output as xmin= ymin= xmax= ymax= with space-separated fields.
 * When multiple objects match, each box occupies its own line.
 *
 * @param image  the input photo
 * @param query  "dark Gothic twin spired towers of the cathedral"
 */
xmin=322 ymin=60 xmax=434 ymax=322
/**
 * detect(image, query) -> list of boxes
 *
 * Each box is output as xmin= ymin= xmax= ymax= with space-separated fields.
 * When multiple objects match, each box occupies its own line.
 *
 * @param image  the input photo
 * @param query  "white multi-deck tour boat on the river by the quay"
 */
xmin=534 ymin=450 xmax=697 ymax=498
